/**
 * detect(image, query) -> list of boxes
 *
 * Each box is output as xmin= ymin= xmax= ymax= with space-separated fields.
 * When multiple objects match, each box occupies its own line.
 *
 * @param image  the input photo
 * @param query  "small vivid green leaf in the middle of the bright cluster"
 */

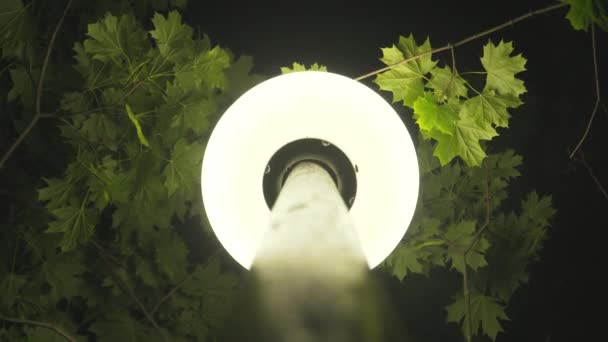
xmin=413 ymin=93 xmax=458 ymax=136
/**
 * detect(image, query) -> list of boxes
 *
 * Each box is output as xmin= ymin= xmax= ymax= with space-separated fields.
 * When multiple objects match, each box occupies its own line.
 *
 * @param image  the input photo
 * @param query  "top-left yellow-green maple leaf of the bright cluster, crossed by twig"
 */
xmin=374 ymin=35 xmax=437 ymax=107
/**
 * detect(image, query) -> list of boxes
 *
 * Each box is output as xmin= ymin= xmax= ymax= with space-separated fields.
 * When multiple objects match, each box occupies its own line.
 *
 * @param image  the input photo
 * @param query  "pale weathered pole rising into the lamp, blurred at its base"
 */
xmin=253 ymin=162 xmax=368 ymax=342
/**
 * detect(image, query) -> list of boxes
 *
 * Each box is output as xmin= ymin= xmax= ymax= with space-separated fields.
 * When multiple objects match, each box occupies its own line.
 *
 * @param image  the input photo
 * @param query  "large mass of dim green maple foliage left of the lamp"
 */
xmin=0 ymin=1 xmax=260 ymax=341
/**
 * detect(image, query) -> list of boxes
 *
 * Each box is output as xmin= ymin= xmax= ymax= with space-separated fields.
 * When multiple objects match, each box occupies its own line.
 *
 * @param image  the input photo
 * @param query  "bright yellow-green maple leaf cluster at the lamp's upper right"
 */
xmin=375 ymin=35 xmax=526 ymax=166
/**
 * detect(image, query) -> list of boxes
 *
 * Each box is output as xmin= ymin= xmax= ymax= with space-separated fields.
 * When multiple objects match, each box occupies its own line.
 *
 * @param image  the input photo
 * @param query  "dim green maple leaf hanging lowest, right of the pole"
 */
xmin=446 ymin=293 xmax=509 ymax=340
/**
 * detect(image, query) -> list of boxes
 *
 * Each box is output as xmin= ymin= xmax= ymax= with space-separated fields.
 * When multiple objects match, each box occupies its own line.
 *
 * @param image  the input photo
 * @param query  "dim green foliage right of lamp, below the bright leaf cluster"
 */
xmin=383 ymin=139 xmax=555 ymax=339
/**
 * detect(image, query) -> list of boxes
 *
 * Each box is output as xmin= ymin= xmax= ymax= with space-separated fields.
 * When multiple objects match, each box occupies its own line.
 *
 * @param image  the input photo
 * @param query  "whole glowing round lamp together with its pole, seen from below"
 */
xmin=201 ymin=71 xmax=419 ymax=341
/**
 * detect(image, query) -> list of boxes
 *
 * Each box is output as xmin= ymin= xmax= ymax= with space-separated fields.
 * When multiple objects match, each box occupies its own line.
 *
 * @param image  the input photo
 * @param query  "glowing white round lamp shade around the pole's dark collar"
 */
xmin=201 ymin=71 xmax=419 ymax=269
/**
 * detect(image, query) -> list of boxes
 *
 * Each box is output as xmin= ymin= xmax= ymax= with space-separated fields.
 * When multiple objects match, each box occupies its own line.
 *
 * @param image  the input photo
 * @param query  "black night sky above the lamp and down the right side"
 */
xmin=180 ymin=0 xmax=608 ymax=341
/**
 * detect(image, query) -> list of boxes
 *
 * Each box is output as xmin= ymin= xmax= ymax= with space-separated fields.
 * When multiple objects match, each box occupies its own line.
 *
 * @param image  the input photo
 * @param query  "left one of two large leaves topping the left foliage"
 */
xmin=84 ymin=14 xmax=147 ymax=65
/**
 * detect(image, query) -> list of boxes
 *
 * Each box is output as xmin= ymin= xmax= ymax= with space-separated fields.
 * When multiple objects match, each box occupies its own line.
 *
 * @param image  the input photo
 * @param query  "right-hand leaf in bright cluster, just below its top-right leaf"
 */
xmin=460 ymin=89 xmax=522 ymax=127
